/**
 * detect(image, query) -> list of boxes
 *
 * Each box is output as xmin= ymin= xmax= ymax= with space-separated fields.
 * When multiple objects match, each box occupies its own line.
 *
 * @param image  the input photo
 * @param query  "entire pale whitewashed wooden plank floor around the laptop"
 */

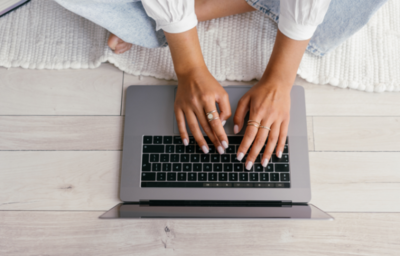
xmin=0 ymin=64 xmax=400 ymax=256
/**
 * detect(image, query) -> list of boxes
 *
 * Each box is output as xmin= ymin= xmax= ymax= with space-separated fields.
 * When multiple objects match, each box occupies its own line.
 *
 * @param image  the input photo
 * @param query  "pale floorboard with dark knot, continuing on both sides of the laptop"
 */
xmin=0 ymin=151 xmax=400 ymax=212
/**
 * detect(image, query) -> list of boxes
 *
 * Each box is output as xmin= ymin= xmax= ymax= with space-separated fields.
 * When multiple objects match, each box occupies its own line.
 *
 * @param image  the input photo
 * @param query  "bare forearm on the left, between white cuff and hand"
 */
xmin=165 ymin=28 xmax=206 ymax=78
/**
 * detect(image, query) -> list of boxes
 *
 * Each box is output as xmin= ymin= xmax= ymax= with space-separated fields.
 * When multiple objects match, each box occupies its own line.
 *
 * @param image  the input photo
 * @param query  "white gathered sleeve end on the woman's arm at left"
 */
xmin=142 ymin=0 xmax=197 ymax=33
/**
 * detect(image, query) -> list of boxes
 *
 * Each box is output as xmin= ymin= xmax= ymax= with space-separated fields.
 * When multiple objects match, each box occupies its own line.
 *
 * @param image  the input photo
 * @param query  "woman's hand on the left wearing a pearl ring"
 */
xmin=174 ymin=67 xmax=231 ymax=154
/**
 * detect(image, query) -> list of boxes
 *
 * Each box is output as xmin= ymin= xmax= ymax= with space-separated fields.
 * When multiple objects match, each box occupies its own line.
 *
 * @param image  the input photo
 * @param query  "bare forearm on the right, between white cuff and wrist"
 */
xmin=260 ymin=30 xmax=310 ymax=90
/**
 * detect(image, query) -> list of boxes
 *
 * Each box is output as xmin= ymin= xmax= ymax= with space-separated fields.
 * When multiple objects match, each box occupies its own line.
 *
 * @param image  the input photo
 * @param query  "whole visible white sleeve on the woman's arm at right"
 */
xmin=278 ymin=0 xmax=331 ymax=40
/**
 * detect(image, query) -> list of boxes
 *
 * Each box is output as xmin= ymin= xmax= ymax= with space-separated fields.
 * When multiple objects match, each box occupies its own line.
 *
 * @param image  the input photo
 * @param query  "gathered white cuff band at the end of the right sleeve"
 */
xmin=278 ymin=15 xmax=318 ymax=41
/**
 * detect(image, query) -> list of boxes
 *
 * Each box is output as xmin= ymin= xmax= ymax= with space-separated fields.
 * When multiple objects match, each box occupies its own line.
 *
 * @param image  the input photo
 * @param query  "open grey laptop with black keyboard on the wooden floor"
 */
xmin=100 ymin=86 xmax=333 ymax=220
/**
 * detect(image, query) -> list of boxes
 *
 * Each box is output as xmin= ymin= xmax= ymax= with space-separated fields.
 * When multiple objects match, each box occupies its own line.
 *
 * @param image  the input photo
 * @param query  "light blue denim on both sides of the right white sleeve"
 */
xmin=246 ymin=0 xmax=387 ymax=56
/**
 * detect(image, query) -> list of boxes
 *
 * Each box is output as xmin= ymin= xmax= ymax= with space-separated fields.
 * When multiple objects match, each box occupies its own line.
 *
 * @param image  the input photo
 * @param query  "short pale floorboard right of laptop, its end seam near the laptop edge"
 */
xmin=313 ymin=117 xmax=400 ymax=151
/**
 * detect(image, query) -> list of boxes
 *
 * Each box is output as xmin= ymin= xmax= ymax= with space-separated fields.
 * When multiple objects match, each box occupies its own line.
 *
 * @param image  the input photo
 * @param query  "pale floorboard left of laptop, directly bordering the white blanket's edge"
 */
xmin=0 ymin=64 xmax=123 ymax=115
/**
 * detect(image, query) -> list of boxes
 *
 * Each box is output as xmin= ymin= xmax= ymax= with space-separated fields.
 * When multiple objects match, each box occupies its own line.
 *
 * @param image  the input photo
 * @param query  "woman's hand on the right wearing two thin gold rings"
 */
xmin=233 ymin=81 xmax=291 ymax=170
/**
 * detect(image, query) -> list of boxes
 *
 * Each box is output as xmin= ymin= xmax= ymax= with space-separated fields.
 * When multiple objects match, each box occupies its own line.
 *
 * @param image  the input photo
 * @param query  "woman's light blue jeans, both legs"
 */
xmin=55 ymin=0 xmax=387 ymax=56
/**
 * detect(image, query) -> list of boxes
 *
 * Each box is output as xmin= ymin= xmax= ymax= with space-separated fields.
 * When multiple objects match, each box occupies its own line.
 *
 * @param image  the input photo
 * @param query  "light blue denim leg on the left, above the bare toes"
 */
xmin=55 ymin=0 xmax=167 ymax=48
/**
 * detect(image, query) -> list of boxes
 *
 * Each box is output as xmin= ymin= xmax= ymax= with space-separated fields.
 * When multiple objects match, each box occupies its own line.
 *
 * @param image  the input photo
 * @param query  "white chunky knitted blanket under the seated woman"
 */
xmin=0 ymin=0 xmax=400 ymax=92
